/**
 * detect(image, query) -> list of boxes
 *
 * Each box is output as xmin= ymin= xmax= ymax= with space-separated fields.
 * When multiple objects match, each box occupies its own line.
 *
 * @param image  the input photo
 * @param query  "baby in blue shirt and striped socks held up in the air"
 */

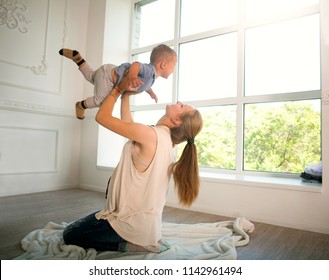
xmin=59 ymin=44 xmax=177 ymax=120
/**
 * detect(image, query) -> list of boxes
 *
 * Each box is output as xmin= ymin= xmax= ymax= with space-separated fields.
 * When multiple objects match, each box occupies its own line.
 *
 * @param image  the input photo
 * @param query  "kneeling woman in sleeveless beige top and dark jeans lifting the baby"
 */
xmin=63 ymin=75 xmax=202 ymax=252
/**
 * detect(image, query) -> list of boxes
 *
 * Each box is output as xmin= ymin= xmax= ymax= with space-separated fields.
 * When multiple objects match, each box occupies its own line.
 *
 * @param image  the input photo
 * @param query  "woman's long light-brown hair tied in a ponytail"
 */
xmin=169 ymin=109 xmax=203 ymax=207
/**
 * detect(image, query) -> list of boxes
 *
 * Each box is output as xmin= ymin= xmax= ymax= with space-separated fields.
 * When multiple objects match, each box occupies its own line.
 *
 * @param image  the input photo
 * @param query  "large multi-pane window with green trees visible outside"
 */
xmin=98 ymin=0 xmax=323 ymax=182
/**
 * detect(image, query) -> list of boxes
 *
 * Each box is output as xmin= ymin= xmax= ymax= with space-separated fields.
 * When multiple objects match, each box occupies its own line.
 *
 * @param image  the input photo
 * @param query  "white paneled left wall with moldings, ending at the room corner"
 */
xmin=0 ymin=0 xmax=89 ymax=196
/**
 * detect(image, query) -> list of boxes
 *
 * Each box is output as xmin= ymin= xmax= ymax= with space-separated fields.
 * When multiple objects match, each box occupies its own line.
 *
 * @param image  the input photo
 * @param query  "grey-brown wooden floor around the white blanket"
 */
xmin=0 ymin=189 xmax=329 ymax=260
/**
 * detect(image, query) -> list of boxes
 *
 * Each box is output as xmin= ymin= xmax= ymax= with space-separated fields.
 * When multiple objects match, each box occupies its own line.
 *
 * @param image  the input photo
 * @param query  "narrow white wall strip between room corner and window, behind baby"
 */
xmin=80 ymin=0 xmax=131 ymax=192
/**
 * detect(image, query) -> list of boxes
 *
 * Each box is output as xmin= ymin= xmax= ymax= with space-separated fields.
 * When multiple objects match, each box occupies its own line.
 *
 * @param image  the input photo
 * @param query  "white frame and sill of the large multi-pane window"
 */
xmin=98 ymin=0 xmax=329 ymax=191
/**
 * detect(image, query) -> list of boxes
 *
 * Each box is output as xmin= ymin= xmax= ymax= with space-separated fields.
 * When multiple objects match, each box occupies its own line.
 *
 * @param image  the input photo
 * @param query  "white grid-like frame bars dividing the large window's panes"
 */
xmin=96 ymin=0 xmax=328 ymax=188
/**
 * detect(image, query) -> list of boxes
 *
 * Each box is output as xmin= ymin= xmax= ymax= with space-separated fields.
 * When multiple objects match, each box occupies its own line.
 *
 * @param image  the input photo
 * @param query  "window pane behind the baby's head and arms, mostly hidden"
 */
xmin=133 ymin=52 xmax=173 ymax=105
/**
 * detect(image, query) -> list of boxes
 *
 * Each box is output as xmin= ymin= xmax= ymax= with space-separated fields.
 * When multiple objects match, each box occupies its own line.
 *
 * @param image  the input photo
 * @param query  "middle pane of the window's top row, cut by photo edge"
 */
xmin=181 ymin=0 xmax=238 ymax=36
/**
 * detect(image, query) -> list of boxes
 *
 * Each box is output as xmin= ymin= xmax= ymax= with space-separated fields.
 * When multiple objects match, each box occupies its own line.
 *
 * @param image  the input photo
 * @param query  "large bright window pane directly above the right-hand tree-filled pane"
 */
xmin=245 ymin=15 xmax=320 ymax=95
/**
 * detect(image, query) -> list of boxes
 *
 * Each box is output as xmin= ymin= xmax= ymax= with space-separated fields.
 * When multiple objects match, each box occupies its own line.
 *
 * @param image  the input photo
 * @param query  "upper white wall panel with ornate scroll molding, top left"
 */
xmin=0 ymin=0 xmax=67 ymax=95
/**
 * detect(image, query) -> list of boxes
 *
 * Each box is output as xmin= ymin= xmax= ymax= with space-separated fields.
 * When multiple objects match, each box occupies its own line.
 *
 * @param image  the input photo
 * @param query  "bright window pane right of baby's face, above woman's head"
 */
xmin=178 ymin=33 xmax=237 ymax=101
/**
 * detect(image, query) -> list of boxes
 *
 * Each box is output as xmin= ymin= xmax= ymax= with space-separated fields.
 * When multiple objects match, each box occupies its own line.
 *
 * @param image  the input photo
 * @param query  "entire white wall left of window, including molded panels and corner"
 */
xmin=0 ymin=0 xmax=131 ymax=196
